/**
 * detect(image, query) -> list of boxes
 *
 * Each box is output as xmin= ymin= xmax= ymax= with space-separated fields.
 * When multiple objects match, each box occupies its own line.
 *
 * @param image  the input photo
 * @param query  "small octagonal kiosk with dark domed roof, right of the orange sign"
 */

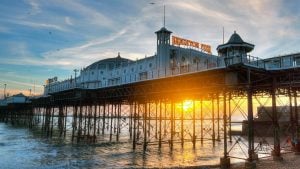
xmin=217 ymin=31 xmax=254 ymax=65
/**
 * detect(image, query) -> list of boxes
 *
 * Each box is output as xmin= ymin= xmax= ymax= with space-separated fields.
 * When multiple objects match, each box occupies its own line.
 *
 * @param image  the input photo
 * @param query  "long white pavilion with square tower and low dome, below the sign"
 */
xmin=44 ymin=28 xmax=225 ymax=95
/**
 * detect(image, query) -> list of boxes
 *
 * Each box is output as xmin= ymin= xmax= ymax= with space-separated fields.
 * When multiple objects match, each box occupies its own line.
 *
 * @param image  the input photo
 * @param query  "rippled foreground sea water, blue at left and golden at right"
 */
xmin=0 ymin=123 xmax=248 ymax=169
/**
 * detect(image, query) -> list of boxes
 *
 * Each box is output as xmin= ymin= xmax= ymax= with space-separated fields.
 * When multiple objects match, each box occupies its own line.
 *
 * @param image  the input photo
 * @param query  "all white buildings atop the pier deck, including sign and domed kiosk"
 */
xmin=44 ymin=27 xmax=300 ymax=95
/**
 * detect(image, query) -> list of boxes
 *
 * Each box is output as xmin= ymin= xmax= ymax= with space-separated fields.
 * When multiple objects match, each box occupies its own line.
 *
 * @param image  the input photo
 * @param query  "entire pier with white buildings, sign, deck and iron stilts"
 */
xmin=0 ymin=27 xmax=300 ymax=168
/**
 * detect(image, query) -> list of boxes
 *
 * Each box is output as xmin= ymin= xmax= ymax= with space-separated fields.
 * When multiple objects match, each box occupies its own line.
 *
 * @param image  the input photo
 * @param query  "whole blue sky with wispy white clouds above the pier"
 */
xmin=0 ymin=0 xmax=300 ymax=97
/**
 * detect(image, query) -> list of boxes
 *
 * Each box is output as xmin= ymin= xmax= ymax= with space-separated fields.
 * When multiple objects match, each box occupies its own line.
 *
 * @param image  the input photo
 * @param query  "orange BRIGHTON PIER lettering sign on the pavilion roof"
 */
xmin=172 ymin=36 xmax=211 ymax=54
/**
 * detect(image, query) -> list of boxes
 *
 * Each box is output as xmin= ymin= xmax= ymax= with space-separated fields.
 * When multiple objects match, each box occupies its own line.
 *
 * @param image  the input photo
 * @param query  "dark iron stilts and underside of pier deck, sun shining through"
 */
xmin=0 ymin=54 xmax=300 ymax=168
